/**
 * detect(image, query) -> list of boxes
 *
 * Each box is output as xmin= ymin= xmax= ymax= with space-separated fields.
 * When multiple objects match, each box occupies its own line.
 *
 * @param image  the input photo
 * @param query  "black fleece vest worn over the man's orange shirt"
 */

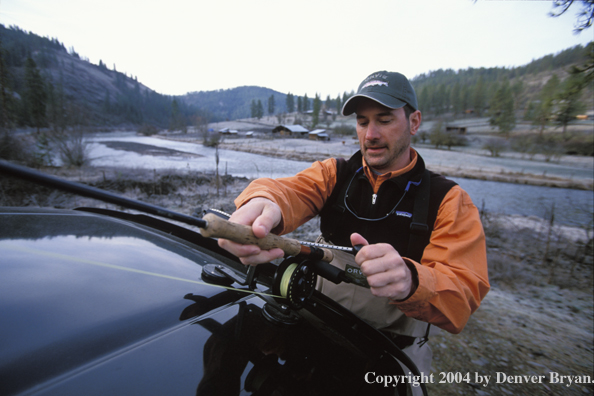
xmin=320 ymin=151 xmax=456 ymax=262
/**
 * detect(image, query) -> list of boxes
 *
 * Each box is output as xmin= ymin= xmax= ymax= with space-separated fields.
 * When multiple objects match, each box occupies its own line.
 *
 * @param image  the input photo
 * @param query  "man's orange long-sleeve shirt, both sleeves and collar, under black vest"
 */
xmin=235 ymin=149 xmax=490 ymax=333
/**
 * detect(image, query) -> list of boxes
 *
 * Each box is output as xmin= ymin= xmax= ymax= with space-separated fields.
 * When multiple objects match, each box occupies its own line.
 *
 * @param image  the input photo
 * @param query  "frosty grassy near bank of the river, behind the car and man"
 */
xmin=0 ymin=161 xmax=594 ymax=396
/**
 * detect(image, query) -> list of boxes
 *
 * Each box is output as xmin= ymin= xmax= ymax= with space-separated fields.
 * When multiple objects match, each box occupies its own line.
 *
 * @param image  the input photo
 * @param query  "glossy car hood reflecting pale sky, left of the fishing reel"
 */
xmin=0 ymin=208 xmax=245 ymax=393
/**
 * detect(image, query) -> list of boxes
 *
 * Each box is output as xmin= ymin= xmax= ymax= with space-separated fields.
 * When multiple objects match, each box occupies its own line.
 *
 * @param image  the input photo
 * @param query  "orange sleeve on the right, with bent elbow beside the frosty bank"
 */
xmin=394 ymin=186 xmax=490 ymax=334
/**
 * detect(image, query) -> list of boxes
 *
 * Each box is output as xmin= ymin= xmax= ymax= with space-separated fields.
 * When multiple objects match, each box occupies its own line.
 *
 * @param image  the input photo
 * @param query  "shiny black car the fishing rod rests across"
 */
xmin=0 ymin=162 xmax=426 ymax=395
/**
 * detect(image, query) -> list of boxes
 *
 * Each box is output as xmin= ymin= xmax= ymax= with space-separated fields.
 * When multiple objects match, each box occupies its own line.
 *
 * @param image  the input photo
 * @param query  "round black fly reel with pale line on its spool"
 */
xmin=272 ymin=257 xmax=316 ymax=309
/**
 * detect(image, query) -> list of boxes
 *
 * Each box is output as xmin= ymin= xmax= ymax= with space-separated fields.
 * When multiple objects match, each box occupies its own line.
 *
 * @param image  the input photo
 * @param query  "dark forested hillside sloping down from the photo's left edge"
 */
xmin=0 ymin=25 xmax=199 ymax=127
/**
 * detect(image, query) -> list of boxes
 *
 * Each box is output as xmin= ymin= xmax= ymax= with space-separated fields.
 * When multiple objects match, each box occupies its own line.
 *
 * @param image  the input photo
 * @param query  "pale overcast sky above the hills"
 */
xmin=0 ymin=0 xmax=594 ymax=99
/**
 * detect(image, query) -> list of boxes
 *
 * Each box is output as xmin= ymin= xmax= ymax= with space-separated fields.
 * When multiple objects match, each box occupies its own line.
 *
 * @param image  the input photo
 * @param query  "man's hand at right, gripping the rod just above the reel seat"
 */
xmin=351 ymin=233 xmax=414 ymax=300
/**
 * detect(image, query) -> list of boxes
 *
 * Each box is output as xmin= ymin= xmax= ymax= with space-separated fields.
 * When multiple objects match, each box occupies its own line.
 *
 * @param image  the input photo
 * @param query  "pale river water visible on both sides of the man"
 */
xmin=85 ymin=133 xmax=594 ymax=227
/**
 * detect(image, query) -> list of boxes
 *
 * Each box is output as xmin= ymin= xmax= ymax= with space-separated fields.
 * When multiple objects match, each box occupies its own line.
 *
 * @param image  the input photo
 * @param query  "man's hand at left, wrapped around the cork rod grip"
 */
xmin=219 ymin=198 xmax=284 ymax=265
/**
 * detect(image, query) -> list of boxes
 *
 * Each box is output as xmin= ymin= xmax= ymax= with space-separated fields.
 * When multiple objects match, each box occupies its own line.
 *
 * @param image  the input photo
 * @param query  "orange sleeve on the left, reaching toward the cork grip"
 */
xmin=235 ymin=158 xmax=336 ymax=235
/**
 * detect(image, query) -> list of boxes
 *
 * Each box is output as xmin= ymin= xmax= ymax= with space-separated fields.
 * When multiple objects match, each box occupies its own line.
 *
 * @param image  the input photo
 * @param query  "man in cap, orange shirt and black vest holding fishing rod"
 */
xmin=219 ymin=71 xmax=489 ymax=380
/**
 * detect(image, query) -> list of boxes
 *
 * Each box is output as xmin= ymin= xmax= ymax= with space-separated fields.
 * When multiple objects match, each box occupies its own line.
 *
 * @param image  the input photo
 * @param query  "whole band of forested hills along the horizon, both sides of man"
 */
xmin=0 ymin=25 xmax=594 ymax=135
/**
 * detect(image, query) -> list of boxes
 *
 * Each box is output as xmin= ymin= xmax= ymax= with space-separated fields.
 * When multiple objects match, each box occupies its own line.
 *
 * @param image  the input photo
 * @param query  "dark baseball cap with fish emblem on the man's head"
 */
xmin=342 ymin=71 xmax=419 ymax=115
